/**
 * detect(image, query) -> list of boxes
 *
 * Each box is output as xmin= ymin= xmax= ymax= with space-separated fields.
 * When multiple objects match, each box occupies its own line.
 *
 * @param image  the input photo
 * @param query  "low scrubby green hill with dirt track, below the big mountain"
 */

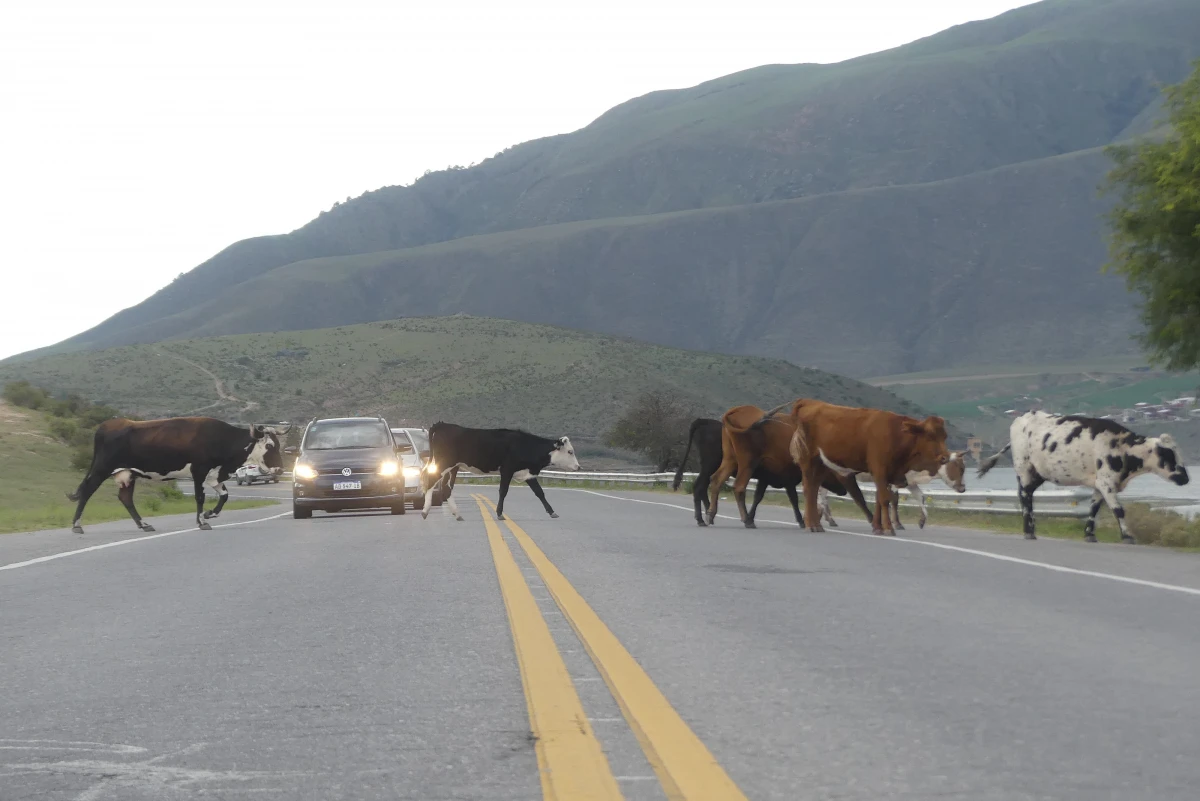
xmin=0 ymin=317 xmax=940 ymax=439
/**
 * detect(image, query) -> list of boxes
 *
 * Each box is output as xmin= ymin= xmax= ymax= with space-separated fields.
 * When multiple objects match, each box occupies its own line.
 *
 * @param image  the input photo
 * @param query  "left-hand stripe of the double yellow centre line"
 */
xmin=472 ymin=495 xmax=624 ymax=801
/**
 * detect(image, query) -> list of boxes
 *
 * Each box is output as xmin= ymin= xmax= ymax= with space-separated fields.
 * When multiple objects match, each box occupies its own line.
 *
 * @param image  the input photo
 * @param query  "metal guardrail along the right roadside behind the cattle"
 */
xmin=448 ymin=470 xmax=1092 ymax=518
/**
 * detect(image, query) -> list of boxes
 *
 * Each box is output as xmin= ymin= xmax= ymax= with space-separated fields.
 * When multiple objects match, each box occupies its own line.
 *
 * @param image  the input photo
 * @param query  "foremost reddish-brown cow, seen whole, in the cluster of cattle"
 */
xmin=790 ymin=398 xmax=950 ymax=536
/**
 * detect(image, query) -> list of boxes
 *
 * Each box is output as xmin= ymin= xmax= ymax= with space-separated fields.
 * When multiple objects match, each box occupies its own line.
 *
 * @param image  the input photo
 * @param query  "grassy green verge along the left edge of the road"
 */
xmin=0 ymin=401 xmax=271 ymax=534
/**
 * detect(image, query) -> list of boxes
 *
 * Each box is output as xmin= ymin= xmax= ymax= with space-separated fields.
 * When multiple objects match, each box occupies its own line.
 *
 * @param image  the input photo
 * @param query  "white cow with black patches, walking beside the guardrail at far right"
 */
xmin=977 ymin=411 xmax=1188 ymax=542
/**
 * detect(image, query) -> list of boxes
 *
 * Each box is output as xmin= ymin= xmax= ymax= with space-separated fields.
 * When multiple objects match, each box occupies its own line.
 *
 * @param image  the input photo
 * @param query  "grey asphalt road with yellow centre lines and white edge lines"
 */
xmin=0 ymin=484 xmax=1200 ymax=801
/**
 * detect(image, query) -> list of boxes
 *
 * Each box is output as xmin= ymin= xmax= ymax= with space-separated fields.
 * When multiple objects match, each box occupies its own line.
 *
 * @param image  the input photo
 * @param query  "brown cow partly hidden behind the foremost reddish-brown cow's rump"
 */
xmin=697 ymin=404 xmax=871 ymax=529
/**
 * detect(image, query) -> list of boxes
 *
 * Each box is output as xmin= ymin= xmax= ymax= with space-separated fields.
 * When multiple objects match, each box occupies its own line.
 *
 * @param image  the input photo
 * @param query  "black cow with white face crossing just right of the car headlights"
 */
xmin=421 ymin=422 xmax=580 ymax=520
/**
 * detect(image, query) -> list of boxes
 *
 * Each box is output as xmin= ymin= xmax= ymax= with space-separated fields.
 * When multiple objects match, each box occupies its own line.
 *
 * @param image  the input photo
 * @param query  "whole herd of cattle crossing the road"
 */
xmin=60 ymin=398 xmax=1188 ymax=542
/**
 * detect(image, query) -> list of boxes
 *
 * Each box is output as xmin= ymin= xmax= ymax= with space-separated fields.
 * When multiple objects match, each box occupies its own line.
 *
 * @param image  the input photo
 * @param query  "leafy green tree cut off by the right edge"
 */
xmin=1104 ymin=61 xmax=1200 ymax=369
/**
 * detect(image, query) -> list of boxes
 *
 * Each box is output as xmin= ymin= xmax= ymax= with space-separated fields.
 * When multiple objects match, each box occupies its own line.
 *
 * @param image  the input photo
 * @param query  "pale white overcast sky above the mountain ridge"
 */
xmin=0 ymin=0 xmax=1030 ymax=359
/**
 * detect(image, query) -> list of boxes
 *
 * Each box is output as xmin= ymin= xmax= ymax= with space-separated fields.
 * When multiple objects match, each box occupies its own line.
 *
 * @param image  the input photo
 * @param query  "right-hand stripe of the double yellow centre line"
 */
xmin=476 ymin=496 xmax=746 ymax=801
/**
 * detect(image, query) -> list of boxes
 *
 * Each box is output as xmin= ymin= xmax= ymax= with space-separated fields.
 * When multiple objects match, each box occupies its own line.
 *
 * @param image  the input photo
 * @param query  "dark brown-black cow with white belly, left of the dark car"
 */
xmin=67 ymin=417 xmax=292 ymax=534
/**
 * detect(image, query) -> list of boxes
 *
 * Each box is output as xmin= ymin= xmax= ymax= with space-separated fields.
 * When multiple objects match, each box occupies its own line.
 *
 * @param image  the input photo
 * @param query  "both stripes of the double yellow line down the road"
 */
xmin=473 ymin=494 xmax=746 ymax=801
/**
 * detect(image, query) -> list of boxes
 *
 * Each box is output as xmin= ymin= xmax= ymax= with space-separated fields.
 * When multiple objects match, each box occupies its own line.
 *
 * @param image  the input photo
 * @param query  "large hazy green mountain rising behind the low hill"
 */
xmin=18 ymin=0 xmax=1200 ymax=375
